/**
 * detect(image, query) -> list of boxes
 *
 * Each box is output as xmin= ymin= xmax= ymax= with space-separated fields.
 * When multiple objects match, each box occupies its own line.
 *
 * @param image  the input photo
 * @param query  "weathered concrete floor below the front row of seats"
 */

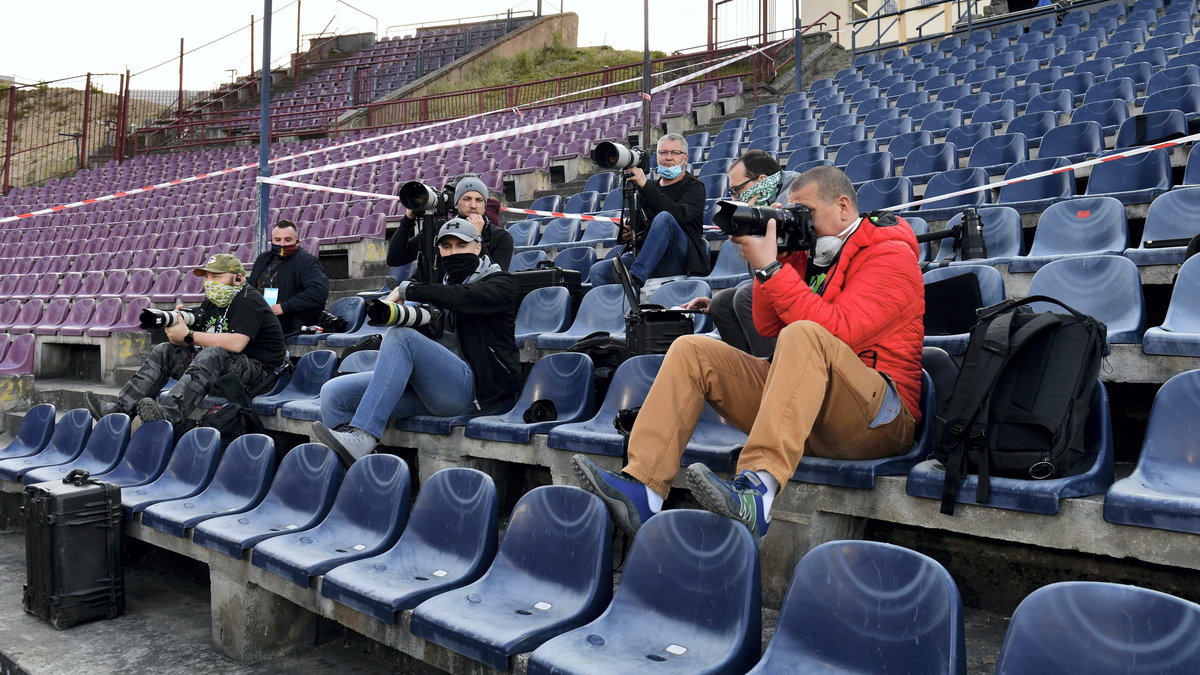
xmin=0 ymin=533 xmax=1008 ymax=675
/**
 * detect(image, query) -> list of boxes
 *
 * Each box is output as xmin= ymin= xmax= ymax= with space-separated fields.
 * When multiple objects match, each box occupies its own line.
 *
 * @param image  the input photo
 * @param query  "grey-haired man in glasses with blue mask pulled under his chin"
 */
xmin=589 ymin=133 xmax=712 ymax=288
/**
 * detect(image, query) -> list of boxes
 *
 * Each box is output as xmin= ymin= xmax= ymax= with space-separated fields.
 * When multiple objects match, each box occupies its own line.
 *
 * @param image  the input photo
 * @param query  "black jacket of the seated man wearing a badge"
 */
xmin=247 ymin=249 xmax=329 ymax=334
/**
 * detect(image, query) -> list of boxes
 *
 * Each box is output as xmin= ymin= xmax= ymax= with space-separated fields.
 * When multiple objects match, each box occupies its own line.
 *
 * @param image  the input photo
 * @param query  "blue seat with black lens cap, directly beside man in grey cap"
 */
xmin=464 ymin=352 xmax=595 ymax=444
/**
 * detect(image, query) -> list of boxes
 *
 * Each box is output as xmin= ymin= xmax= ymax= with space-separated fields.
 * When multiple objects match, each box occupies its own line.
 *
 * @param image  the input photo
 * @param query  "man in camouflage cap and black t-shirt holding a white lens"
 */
xmin=84 ymin=253 xmax=287 ymax=425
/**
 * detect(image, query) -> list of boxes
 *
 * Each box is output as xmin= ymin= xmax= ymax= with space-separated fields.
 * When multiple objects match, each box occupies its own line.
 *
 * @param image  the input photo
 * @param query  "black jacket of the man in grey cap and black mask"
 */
xmin=404 ymin=266 xmax=521 ymax=410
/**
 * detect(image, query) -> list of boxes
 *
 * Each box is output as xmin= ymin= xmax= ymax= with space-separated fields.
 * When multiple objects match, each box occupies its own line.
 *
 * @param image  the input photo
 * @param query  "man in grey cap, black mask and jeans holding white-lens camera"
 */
xmin=312 ymin=218 xmax=521 ymax=465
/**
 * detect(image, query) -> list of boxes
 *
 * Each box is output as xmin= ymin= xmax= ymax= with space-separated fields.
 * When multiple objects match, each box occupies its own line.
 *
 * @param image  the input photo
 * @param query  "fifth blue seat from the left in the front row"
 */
xmin=121 ymin=426 xmax=221 ymax=520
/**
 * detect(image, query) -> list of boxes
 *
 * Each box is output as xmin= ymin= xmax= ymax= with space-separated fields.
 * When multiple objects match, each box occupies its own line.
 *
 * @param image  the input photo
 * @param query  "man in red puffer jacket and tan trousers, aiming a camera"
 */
xmin=574 ymin=167 xmax=925 ymax=539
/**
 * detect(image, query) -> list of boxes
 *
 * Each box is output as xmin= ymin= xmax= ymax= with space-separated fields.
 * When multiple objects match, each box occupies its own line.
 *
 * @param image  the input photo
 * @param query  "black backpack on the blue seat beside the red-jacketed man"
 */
xmin=934 ymin=295 xmax=1109 ymax=514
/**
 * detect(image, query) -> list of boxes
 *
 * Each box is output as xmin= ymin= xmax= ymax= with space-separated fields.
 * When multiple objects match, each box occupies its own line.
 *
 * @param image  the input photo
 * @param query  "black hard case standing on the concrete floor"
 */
xmin=22 ymin=472 xmax=125 ymax=629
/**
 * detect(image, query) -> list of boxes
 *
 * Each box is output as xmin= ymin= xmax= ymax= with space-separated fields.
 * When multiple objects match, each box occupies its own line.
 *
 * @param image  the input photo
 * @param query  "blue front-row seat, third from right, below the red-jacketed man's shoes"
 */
xmin=528 ymin=509 xmax=762 ymax=675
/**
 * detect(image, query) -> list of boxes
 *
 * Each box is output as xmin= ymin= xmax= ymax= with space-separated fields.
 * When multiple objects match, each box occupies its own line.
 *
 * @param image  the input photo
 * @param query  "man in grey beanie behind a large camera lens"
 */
xmin=388 ymin=173 xmax=512 ymax=281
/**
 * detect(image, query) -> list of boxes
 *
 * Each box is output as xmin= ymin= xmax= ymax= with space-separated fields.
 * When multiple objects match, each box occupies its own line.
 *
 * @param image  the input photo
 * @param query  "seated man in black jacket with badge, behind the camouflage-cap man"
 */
xmin=248 ymin=220 xmax=329 ymax=335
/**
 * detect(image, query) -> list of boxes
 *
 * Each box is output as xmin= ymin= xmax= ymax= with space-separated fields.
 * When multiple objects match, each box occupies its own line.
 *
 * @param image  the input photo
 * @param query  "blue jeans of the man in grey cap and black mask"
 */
xmin=320 ymin=327 xmax=475 ymax=438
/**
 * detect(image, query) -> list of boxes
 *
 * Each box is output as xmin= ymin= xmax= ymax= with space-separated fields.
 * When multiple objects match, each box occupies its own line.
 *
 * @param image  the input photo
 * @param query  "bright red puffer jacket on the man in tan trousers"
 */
xmin=754 ymin=212 xmax=925 ymax=422
